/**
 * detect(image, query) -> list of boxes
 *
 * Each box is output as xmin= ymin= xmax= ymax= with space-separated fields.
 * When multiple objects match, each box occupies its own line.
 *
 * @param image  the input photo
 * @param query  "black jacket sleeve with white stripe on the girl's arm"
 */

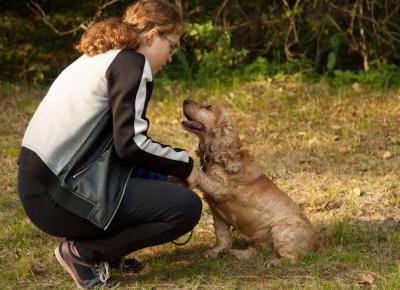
xmin=106 ymin=50 xmax=193 ymax=179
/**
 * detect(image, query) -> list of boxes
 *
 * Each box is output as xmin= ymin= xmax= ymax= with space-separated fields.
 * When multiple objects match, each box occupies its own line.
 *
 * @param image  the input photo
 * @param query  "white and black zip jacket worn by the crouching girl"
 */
xmin=19 ymin=50 xmax=193 ymax=229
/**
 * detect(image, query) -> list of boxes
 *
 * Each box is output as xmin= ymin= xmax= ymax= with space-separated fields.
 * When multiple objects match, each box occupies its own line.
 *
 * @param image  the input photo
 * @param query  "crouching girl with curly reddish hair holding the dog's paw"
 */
xmin=18 ymin=0 xmax=201 ymax=288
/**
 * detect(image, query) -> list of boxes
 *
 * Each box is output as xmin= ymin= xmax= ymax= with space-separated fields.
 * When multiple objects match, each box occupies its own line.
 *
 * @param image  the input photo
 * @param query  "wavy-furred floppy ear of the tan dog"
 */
xmin=210 ymin=122 xmax=241 ymax=173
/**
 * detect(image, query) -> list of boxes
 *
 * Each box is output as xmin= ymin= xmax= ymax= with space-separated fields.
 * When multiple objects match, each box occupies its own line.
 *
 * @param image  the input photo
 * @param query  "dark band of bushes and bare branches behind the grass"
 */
xmin=0 ymin=0 xmax=400 ymax=87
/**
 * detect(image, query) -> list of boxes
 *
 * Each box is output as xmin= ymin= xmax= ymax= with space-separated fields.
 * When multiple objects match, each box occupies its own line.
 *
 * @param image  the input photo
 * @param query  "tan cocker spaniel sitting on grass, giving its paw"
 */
xmin=182 ymin=100 xmax=321 ymax=266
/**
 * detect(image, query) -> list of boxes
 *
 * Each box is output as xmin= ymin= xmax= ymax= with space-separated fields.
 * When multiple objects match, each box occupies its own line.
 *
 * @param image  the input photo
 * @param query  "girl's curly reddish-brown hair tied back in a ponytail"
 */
xmin=75 ymin=0 xmax=183 ymax=56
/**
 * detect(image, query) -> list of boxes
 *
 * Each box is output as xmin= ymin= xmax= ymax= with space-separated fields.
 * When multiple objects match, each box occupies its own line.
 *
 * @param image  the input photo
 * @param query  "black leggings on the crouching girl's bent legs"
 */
xmin=20 ymin=178 xmax=202 ymax=262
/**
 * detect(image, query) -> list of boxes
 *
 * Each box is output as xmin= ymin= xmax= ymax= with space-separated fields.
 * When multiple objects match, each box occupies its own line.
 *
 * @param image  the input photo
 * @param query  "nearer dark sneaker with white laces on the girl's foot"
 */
xmin=55 ymin=240 xmax=119 ymax=289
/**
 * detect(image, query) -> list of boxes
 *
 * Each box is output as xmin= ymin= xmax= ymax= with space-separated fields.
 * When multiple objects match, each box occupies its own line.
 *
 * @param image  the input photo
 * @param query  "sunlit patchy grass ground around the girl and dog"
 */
xmin=0 ymin=78 xmax=400 ymax=289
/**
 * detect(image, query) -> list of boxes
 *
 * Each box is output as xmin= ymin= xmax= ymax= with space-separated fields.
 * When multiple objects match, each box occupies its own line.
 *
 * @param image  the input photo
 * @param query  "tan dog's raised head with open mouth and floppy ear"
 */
xmin=182 ymin=100 xmax=240 ymax=173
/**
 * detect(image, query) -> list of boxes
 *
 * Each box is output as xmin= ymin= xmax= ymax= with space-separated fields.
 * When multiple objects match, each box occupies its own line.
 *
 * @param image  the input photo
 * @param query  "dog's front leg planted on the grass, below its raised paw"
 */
xmin=204 ymin=206 xmax=232 ymax=259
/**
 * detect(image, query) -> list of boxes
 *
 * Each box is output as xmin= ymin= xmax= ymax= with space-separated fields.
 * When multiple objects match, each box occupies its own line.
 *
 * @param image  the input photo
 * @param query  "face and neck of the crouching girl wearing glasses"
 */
xmin=137 ymin=29 xmax=180 ymax=75
